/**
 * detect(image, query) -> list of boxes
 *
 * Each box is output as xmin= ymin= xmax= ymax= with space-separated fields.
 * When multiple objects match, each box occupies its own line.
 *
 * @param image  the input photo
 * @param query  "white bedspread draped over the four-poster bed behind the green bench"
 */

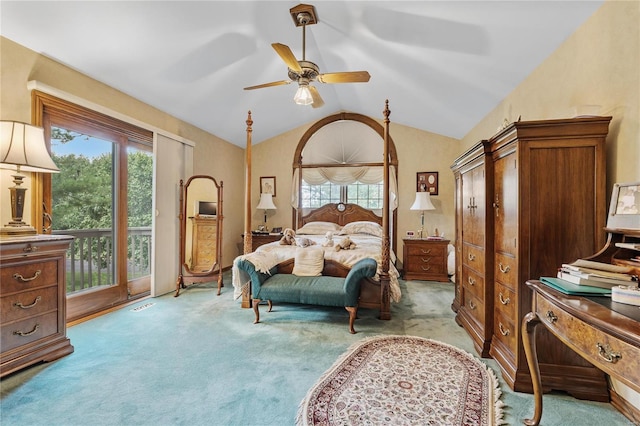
xmin=232 ymin=234 xmax=402 ymax=302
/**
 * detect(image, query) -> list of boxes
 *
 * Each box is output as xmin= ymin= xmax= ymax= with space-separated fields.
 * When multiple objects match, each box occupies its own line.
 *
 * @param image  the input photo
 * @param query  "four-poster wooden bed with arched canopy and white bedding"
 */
xmin=233 ymin=101 xmax=401 ymax=320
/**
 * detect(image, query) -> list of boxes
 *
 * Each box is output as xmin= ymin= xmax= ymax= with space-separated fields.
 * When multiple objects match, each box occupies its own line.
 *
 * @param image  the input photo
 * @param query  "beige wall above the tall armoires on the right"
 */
xmin=462 ymin=0 xmax=640 ymax=187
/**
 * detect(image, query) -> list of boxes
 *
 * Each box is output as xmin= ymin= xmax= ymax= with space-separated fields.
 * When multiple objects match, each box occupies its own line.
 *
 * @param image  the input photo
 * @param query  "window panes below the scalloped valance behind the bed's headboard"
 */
xmin=301 ymin=180 xmax=383 ymax=209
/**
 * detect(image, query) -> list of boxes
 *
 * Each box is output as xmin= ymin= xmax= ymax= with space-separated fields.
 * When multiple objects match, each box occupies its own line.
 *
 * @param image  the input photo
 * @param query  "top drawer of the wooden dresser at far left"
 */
xmin=0 ymin=260 xmax=58 ymax=296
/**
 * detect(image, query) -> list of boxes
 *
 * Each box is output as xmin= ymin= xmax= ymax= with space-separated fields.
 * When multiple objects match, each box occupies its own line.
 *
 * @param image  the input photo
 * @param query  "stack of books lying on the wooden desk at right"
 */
xmin=558 ymin=259 xmax=638 ymax=289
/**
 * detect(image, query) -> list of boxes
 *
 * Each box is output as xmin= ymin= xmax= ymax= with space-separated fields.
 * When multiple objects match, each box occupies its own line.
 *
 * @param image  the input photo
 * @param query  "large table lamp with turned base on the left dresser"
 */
xmin=0 ymin=121 xmax=60 ymax=235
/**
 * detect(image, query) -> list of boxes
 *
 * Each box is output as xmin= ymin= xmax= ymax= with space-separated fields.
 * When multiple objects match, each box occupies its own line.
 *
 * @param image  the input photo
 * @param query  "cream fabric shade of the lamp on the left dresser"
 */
xmin=0 ymin=121 xmax=60 ymax=173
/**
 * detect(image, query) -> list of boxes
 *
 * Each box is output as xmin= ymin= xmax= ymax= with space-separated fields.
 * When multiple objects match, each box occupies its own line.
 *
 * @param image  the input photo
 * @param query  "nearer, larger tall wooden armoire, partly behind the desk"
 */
xmin=490 ymin=117 xmax=611 ymax=401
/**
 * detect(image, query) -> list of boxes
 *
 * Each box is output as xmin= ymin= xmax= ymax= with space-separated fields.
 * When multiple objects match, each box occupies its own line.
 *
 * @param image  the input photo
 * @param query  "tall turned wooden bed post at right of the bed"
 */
xmin=380 ymin=99 xmax=391 ymax=320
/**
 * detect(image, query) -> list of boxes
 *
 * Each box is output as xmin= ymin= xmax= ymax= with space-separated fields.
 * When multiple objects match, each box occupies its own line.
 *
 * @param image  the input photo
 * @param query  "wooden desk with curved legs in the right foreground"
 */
xmin=522 ymin=280 xmax=640 ymax=425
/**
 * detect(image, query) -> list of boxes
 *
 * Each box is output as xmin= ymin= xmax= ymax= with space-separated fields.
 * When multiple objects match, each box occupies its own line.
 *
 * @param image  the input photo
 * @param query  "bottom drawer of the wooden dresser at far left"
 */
xmin=1 ymin=311 xmax=59 ymax=354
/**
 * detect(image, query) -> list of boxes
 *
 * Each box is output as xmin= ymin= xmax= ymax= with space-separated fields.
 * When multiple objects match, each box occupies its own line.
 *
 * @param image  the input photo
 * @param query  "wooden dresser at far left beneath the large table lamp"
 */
xmin=0 ymin=235 xmax=73 ymax=376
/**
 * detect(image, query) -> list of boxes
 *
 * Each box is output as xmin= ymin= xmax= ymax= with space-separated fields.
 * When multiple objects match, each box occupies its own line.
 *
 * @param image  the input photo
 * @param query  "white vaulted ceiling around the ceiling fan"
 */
xmin=0 ymin=0 xmax=603 ymax=146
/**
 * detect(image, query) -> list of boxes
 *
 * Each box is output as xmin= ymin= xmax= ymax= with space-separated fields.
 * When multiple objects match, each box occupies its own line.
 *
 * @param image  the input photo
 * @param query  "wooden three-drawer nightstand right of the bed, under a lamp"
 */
xmin=402 ymin=238 xmax=449 ymax=282
